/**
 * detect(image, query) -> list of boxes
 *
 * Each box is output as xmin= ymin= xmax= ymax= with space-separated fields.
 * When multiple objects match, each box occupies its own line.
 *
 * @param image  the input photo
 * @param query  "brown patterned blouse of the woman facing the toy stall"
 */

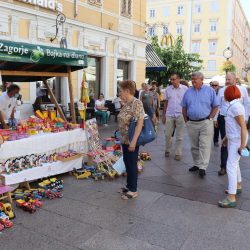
xmin=118 ymin=99 xmax=145 ymax=145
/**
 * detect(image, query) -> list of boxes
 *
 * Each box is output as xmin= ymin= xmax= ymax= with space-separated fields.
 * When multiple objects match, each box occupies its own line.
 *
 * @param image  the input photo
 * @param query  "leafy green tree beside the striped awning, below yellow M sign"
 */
xmin=147 ymin=36 xmax=203 ymax=85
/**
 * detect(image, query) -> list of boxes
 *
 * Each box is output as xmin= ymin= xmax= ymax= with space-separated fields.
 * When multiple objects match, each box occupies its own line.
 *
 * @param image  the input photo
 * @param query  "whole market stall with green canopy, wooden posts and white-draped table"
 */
xmin=0 ymin=40 xmax=88 ymax=188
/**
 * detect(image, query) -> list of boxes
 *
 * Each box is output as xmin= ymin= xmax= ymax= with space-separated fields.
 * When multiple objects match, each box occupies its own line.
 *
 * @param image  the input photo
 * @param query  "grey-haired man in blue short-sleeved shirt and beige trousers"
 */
xmin=182 ymin=72 xmax=219 ymax=178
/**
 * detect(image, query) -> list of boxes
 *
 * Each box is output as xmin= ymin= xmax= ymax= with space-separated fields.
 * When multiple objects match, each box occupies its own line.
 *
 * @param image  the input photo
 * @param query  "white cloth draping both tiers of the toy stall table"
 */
xmin=0 ymin=129 xmax=88 ymax=185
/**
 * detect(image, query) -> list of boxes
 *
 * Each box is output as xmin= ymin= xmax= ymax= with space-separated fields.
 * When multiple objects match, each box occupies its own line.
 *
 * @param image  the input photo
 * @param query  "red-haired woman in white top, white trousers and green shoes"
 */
xmin=218 ymin=85 xmax=247 ymax=208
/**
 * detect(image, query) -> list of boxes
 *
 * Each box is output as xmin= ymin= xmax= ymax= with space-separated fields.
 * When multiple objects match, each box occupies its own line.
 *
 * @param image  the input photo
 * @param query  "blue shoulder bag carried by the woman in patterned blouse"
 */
xmin=128 ymin=100 xmax=156 ymax=146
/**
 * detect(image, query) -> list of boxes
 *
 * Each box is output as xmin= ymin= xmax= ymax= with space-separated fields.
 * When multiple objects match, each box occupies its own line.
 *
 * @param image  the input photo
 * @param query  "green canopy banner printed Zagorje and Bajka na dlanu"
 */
xmin=0 ymin=40 xmax=88 ymax=68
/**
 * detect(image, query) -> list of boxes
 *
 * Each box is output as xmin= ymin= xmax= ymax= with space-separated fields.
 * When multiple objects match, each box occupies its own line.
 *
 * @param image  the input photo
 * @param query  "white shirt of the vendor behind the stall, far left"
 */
xmin=0 ymin=92 xmax=16 ymax=122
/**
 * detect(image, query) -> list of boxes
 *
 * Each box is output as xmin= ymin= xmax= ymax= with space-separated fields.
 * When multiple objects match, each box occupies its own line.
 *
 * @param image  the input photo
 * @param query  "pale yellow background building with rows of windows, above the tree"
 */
xmin=147 ymin=0 xmax=250 ymax=79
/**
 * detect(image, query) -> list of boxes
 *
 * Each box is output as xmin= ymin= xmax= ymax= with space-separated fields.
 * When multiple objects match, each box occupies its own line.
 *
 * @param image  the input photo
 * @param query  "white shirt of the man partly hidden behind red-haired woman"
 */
xmin=216 ymin=85 xmax=250 ymax=121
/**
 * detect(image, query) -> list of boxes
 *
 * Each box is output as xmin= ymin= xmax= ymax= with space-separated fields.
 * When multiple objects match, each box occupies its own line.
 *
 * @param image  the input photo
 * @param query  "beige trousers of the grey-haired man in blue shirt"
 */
xmin=187 ymin=119 xmax=213 ymax=170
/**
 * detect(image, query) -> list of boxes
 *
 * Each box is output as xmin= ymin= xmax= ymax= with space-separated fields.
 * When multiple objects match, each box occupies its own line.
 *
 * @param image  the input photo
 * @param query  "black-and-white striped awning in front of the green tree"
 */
xmin=146 ymin=44 xmax=166 ymax=72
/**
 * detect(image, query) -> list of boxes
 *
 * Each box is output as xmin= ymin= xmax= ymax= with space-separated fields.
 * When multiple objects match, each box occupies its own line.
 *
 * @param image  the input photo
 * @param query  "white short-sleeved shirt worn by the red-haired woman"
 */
xmin=225 ymin=99 xmax=245 ymax=139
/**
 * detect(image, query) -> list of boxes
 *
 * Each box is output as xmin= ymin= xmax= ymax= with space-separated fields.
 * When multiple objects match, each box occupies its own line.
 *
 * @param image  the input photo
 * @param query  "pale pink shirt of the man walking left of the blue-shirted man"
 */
xmin=164 ymin=84 xmax=188 ymax=117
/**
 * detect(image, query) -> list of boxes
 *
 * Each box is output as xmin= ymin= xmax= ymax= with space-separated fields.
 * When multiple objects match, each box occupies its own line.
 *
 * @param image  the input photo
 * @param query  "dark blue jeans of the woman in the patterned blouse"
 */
xmin=122 ymin=144 xmax=139 ymax=192
